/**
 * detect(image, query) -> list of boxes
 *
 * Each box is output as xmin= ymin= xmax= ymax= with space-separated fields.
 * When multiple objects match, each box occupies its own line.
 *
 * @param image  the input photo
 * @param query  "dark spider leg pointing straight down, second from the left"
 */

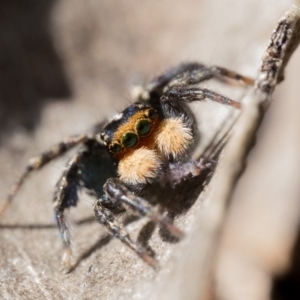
xmin=53 ymin=153 xmax=81 ymax=270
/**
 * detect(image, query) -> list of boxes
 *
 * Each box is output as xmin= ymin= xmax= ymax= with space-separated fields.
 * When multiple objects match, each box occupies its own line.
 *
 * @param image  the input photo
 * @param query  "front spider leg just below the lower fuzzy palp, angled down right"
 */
xmin=104 ymin=178 xmax=183 ymax=238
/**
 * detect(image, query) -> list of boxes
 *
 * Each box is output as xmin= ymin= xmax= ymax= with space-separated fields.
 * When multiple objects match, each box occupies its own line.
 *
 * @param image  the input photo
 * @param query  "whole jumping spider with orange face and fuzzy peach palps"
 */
xmin=0 ymin=63 xmax=253 ymax=269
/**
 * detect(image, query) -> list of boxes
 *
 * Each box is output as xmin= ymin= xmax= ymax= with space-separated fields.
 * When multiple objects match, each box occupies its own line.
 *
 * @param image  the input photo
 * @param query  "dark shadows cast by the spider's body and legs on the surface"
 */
xmin=0 ymin=138 xmax=218 ymax=272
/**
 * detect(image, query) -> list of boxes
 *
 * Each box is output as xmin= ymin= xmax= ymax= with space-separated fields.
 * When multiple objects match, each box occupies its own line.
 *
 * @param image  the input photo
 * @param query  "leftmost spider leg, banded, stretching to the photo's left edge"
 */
xmin=0 ymin=135 xmax=87 ymax=218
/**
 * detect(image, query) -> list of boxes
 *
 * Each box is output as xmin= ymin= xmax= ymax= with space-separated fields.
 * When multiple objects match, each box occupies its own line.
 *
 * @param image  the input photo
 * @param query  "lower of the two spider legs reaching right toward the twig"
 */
xmin=161 ymin=87 xmax=241 ymax=108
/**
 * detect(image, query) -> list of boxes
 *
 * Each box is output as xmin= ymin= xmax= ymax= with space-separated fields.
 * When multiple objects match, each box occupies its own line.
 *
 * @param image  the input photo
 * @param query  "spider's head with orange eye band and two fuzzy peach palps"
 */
xmin=101 ymin=103 xmax=193 ymax=185
